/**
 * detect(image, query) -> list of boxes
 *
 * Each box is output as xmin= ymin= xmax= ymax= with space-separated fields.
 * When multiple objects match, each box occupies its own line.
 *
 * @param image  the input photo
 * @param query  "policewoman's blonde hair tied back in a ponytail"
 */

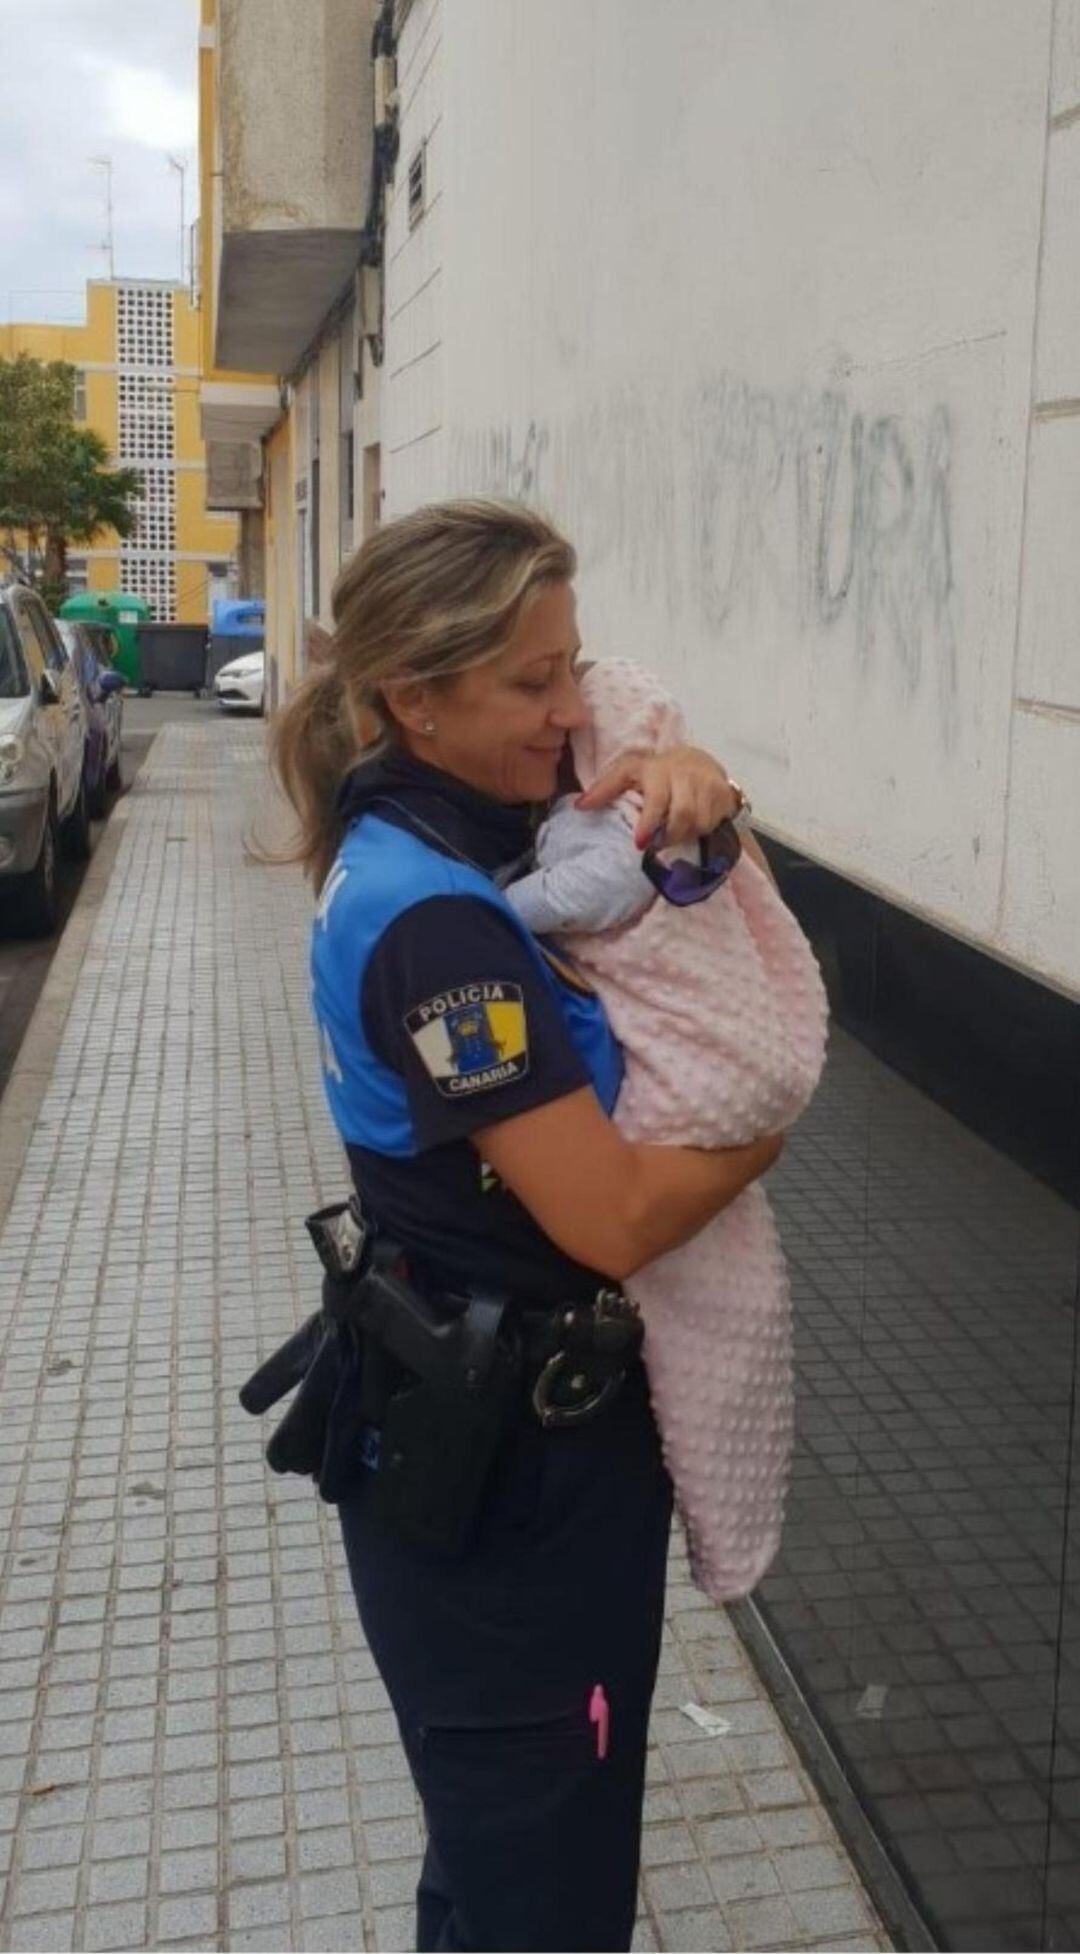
xmin=271 ymin=498 xmax=578 ymax=889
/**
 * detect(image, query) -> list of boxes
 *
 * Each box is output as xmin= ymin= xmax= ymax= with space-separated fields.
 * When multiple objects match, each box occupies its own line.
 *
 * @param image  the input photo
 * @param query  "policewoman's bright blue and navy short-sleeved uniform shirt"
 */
xmin=312 ymin=750 xmax=621 ymax=1303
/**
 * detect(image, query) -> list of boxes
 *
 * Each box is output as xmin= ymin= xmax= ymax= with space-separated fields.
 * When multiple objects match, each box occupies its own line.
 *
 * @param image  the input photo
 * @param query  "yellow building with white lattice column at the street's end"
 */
xmin=0 ymin=279 xmax=238 ymax=623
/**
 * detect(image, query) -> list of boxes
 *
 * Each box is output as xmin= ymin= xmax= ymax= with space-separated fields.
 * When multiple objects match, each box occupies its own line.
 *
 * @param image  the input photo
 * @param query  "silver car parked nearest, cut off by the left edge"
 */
xmin=0 ymin=584 xmax=90 ymax=936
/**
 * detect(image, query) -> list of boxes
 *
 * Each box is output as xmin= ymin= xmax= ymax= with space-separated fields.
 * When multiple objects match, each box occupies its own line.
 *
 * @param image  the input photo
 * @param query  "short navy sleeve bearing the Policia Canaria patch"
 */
xmin=359 ymin=895 xmax=590 ymax=1149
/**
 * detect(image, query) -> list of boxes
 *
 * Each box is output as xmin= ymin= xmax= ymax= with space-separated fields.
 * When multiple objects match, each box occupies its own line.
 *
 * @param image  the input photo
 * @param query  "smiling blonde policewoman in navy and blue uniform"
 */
xmin=265 ymin=502 xmax=779 ymax=1950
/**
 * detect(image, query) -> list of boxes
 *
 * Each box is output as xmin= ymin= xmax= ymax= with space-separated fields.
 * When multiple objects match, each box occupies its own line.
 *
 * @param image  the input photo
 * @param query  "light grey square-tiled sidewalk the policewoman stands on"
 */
xmin=0 ymin=713 xmax=891 ymax=1950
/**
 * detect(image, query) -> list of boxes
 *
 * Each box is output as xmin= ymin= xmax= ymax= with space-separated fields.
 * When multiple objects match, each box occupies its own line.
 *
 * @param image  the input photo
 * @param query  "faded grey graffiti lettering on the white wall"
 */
xmin=451 ymin=375 xmax=957 ymax=741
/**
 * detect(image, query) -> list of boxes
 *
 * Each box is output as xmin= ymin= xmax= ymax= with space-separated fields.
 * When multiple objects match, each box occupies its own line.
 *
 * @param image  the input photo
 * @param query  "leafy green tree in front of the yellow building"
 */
xmin=0 ymin=354 xmax=143 ymax=604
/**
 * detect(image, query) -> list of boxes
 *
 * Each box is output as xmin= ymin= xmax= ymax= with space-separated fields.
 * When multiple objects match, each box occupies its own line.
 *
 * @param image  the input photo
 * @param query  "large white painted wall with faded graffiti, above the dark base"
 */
xmin=387 ymin=0 xmax=1080 ymax=989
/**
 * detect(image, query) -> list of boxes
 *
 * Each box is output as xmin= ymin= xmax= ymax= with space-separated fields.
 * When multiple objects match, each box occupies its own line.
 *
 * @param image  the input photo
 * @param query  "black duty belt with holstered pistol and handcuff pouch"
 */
xmin=240 ymin=1202 xmax=643 ymax=1553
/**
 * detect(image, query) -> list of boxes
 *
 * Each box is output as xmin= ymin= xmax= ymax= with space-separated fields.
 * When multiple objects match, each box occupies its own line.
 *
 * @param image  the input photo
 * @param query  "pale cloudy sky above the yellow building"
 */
xmin=0 ymin=0 xmax=199 ymax=320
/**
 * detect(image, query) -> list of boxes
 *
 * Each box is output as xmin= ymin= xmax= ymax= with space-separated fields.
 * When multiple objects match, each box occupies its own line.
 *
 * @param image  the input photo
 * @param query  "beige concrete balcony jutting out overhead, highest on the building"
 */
xmin=215 ymin=0 xmax=379 ymax=373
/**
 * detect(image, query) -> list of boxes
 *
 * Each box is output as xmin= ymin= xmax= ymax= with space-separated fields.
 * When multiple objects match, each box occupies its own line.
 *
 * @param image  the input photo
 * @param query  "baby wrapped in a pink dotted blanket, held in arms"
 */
xmin=506 ymin=658 xmax=826 ymax=1600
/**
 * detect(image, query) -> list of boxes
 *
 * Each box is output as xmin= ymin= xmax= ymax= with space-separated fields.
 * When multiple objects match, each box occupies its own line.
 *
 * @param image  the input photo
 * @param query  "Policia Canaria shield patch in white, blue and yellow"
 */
xmin=404 ymin=981 xmax=529 ymax=1098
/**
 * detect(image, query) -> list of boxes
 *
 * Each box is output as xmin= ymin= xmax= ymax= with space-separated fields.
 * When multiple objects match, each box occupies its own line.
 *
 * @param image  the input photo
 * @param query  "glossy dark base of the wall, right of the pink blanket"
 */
xmin=756 ymin=852 xmax=1080 ymax=1948
